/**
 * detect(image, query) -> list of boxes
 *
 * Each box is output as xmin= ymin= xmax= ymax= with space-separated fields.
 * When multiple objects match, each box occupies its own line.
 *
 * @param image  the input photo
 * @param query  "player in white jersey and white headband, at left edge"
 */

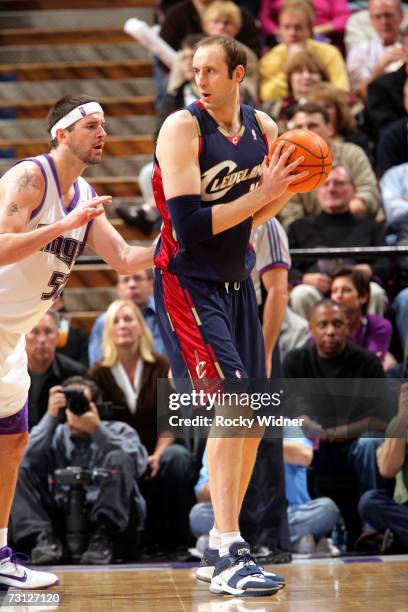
xmin=0 ymin=96 xmax=153 ymax=589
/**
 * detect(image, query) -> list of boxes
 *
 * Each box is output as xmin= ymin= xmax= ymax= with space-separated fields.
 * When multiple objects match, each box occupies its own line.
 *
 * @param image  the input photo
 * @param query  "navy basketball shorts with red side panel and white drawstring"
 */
xmin=154 ymin=269 xmax=266 ymax=380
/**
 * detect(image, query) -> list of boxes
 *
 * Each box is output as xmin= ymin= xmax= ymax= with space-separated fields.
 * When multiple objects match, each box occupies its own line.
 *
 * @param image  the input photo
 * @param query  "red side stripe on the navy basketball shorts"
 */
xmin=162 ymin=272 xmax=220 ymax=391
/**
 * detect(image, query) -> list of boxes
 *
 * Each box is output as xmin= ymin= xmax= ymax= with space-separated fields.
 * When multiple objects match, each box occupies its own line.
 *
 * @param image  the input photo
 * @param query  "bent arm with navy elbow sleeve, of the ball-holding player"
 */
xmin=157 ymin=111 xmax=302 ymax=244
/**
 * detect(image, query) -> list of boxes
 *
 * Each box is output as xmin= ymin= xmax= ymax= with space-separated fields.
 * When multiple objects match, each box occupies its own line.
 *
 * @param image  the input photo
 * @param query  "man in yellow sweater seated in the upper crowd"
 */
xmin=259 ymin=0 xmax=349 ymax=101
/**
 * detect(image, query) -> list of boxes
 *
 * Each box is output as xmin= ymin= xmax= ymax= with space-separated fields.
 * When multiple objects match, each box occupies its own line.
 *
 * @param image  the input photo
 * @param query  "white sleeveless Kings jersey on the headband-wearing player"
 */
xmin=0 ymin=154 xmax=95 ymax=334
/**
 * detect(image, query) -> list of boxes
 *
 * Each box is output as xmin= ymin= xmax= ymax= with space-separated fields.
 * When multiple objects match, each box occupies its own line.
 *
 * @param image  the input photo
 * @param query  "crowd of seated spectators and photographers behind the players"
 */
xmin=11 ymin=0 xmax=408 ymax=564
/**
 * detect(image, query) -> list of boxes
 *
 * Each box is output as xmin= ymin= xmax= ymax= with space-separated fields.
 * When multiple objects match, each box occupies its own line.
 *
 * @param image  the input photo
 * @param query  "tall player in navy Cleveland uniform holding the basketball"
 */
xmin=153 ymin=36 xmax=308 ymax=596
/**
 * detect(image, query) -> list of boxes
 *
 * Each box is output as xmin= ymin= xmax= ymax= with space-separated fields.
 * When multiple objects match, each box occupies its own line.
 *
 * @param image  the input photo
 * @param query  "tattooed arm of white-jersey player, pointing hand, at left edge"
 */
xmin=0 ymin=161 xmax=111 ymax=266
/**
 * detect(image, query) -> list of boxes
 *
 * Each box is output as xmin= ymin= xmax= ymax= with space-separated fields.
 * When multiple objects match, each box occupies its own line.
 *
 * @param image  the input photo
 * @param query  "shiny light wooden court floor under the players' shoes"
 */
xmin=0 ymin=556 xmax=408 ymax=612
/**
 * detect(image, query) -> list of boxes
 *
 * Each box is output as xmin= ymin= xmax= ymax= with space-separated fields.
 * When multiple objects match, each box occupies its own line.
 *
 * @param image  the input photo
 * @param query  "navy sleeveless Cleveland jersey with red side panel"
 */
xmin=153 ymin=100 xmax=268 ymax=282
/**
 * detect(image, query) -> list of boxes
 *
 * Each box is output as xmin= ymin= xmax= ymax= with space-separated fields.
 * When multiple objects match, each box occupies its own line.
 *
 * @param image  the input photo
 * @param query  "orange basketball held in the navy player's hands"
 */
xmin=268 ymin=130 xmax=333 ymax=193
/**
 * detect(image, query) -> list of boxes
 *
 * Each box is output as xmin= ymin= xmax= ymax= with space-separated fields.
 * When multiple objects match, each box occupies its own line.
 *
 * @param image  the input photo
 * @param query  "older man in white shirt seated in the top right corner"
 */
xmin=347 ymin=0 xmax=405 ymax=100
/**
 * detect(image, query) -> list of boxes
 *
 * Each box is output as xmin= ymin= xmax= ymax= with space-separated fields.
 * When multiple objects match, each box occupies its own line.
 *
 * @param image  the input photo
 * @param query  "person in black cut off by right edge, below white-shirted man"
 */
xmin=366 ymin=26 xmax=408 ymax=142
